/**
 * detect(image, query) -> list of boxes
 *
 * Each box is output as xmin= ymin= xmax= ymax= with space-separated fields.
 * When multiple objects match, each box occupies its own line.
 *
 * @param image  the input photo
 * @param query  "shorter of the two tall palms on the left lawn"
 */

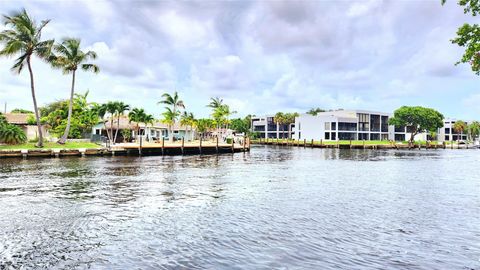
xmin=52 ymin=38 xmax=100 ymax=144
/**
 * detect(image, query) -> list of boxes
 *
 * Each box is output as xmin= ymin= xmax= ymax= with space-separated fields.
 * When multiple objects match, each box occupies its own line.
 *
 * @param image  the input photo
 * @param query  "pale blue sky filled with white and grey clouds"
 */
xmin=0 ymin=0 xmax=480 ymax=120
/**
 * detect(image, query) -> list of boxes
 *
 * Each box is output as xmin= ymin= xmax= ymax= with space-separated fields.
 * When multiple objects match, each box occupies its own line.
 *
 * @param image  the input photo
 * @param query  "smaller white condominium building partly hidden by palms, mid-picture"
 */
xmin=251 ymin=115 xmax=294 ymax=139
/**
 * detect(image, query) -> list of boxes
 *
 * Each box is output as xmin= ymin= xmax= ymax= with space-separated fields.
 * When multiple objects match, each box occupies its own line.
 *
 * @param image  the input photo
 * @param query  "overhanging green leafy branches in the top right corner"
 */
xmin=442 ymin=0 xmax=480 ymax=75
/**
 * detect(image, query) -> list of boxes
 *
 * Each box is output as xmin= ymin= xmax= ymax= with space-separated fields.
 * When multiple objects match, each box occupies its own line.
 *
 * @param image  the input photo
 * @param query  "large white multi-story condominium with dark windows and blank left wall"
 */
xmin=295 ymin=110 xmax=427 ymax=141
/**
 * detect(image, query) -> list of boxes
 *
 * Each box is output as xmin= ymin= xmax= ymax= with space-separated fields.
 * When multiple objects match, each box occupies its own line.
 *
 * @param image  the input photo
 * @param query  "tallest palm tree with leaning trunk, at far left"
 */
xmin=0 ymin=9 xmax=54 ymax=147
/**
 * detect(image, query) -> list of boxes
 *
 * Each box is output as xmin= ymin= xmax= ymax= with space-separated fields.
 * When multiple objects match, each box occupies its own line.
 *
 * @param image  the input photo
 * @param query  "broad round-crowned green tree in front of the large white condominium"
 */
xmin=388 ymin=106 xmax=443 ymax=143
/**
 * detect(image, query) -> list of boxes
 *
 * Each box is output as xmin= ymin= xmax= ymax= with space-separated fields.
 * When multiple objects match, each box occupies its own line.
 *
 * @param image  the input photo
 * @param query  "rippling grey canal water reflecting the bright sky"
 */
xmin=0 ymin=146 xmax=480 ymax=269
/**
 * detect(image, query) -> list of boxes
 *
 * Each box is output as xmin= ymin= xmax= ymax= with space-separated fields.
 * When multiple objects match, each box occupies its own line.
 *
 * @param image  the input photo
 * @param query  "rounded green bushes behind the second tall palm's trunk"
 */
xmin=40 ymin=92 xmax=98 ymax=139
